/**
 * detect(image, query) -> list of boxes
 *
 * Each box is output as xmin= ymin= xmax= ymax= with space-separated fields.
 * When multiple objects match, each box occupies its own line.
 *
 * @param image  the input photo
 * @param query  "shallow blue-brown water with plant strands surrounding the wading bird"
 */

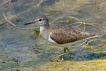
xmin=0 ymin=0 xmax=106 ymax=71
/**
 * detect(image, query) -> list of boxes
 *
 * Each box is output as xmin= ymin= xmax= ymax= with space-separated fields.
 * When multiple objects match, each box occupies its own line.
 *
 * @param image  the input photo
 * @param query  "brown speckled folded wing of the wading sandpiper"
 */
xmin=50 ymin=27 xmax=94 ymax=44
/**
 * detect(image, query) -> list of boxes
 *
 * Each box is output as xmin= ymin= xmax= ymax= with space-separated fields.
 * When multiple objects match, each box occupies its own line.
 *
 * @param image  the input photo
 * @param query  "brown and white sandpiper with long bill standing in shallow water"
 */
xmin=25 ymin=16 xmax=97 ymax=61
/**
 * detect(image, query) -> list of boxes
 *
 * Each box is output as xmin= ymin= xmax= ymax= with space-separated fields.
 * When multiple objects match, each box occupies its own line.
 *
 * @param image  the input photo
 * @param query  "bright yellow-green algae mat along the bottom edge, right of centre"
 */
xmin=39 ymin=59 xmax=106 ymax=71
